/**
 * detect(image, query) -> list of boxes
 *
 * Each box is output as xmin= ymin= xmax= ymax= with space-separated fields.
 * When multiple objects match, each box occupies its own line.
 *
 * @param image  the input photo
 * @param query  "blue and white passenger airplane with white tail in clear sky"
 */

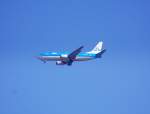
xmin=37 ymin=41 xmax=106 ymax=66
